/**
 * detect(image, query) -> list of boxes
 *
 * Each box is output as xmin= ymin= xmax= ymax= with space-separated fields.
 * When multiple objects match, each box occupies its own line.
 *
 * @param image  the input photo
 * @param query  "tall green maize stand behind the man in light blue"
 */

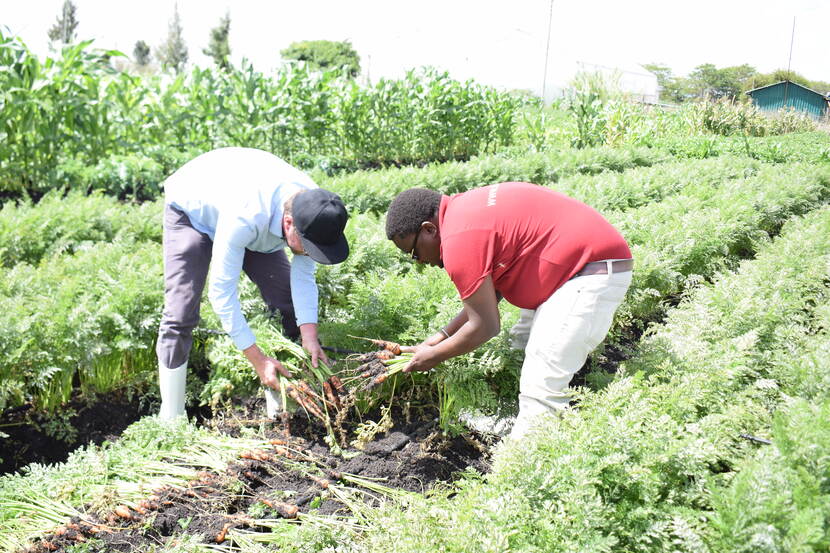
xmin=0 ymin=31 xmax=523 ymax=198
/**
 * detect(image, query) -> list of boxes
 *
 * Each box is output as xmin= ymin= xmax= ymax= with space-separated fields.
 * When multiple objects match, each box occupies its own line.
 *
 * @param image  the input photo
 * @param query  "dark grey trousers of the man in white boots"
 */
xmin=156 ymin=206 xmax=300 ymax=368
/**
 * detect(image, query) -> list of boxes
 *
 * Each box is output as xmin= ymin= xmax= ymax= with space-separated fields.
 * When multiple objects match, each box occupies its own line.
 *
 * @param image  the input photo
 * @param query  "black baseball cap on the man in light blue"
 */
xmin=291 ymin=188 xmax=349 ymax=265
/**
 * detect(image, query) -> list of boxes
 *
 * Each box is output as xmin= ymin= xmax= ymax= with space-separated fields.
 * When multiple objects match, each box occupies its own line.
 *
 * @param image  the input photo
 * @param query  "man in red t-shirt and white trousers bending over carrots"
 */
xmin=386 ymin=182 xmax=633 ymax=438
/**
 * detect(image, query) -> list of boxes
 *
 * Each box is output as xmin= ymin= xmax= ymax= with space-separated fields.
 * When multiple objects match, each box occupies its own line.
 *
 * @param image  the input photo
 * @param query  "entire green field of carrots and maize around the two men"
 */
xmin=0 ymin=35 xmax=830 ymax=553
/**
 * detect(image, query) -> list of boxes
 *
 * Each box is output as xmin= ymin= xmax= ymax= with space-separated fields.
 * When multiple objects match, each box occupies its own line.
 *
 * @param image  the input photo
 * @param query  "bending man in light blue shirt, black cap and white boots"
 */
xmin=156 ymin=148 xmax=349 ymax=419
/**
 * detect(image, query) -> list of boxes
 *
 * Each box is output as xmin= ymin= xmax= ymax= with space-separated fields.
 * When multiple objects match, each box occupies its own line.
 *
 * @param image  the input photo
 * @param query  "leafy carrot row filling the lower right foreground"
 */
xmin=290 ymin=203 xmax=830 ymax=552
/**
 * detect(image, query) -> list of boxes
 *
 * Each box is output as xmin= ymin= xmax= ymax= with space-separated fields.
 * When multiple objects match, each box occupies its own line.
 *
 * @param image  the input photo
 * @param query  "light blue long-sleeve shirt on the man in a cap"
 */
xmin=164 ymin=148 xmax=318 ymax=349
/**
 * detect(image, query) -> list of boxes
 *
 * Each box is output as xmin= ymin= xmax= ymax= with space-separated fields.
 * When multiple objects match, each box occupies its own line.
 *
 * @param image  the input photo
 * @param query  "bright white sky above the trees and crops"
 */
xmin=0 ymin=0 xmax=830 ymax=98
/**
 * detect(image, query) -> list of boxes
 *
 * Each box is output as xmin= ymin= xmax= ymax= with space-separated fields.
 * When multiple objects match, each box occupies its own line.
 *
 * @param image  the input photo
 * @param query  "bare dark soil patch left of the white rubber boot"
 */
xmin=0 ymin=392 xmax=151 ymax=475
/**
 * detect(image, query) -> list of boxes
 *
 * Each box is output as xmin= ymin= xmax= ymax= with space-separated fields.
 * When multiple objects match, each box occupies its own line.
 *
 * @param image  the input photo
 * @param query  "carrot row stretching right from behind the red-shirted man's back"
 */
xmin=609 ymin=157 xmax=830 ymax=334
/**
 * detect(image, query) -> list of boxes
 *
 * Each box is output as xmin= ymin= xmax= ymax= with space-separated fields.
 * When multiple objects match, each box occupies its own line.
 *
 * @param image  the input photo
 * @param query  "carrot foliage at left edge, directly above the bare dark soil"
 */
xmin=0 ymin=240 xmax=163 ymax=410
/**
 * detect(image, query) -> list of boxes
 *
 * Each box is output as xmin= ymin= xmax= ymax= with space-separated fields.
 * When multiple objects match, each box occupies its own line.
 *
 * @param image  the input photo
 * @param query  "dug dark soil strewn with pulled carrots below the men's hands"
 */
xmin=24 ymin=399 xmax=489 ymax=553
